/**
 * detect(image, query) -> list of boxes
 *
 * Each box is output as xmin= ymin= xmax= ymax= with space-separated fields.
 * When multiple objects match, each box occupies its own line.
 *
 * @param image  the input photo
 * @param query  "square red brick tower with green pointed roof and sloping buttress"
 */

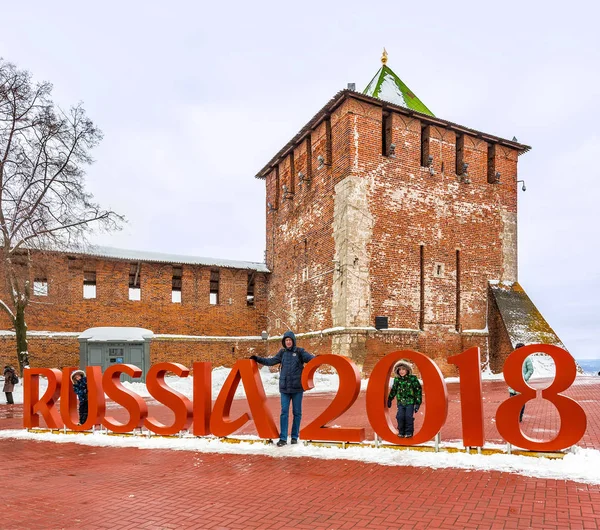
xmin=257 ymin=51 xmax=562 ymax=375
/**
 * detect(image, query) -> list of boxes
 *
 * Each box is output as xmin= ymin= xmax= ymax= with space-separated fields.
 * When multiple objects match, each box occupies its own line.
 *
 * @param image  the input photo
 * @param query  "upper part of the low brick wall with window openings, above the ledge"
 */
xmin=0 ymin=254 xmax=267 ymax=336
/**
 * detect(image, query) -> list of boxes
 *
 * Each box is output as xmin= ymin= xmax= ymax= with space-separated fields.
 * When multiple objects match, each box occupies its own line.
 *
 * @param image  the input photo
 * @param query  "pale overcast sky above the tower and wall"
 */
xmin=0 ymin=0 xmax=600 ymax=358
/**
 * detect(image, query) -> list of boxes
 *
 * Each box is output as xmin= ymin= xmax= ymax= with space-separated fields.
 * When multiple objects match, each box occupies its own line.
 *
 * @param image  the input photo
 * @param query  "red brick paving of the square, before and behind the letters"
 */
xmin=0 ymin=378 xmax=600 ymax=530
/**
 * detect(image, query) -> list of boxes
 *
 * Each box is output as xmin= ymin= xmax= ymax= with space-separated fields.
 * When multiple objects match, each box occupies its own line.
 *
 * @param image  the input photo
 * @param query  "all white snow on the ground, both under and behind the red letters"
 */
xmin=0 ymin=355 xmax=600 ymax=484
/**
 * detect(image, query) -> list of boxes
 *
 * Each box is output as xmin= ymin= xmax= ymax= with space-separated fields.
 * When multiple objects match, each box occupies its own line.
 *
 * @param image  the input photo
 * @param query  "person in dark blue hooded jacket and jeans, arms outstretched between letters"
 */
xmin=250 ymin=331 xmax=315 ymax=447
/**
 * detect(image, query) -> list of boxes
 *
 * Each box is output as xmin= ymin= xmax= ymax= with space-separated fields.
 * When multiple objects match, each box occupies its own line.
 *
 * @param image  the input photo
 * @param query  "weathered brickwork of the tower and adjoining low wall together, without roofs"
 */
xmin=0 ymin=92 xmax=518 ymax=375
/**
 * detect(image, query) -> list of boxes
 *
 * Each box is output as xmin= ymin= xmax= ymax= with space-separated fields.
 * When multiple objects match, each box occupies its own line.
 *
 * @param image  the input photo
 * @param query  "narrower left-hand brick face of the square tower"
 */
xmin=266 ymin=104 xmax=349 ymax=335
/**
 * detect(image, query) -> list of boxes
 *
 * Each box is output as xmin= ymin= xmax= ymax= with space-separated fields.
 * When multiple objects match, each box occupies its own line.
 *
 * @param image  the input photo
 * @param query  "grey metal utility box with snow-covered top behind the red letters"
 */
xmin=79 ymin=327 xmax=154 ymax=382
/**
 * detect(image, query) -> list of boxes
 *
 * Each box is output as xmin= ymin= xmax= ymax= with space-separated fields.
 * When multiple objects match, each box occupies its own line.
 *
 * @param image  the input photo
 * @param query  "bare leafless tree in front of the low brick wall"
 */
xmin=0 ymin=59 xmax=124 ymax=370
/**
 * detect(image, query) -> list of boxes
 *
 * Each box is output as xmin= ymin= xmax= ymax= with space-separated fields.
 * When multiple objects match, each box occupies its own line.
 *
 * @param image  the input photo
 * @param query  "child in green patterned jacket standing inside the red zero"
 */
xmin=387 ymin=360 xmax=423 ymax=438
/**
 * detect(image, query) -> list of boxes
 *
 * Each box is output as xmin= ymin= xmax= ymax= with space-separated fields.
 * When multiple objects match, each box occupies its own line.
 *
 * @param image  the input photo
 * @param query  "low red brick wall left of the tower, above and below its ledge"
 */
xmin=0 ymin=254 xmax=267 ymax=367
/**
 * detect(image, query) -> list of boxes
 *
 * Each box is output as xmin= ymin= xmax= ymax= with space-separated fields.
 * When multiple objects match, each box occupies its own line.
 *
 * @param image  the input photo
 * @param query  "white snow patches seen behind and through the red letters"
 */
xmin=2 ymin=354 xmax=576 ymax=404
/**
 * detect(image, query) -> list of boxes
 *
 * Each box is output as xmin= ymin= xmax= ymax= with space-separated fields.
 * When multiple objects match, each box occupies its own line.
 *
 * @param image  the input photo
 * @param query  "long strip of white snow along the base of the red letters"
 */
xmin=0 ymin=430 xmax=600 ymax=484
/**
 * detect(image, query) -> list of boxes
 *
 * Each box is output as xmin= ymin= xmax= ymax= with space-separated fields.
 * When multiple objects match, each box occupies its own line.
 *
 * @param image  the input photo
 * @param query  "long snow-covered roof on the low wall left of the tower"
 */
xmin=64 ymin=246 xmax=269 ymax=272
